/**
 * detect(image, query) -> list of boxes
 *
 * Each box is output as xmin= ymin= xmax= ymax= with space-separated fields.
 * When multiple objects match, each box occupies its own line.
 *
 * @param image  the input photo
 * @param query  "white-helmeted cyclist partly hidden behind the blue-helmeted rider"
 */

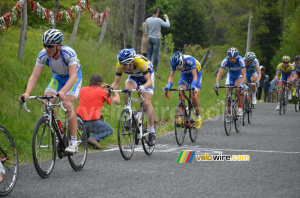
xmin=244 ymin=52 xmax=261 ymax=104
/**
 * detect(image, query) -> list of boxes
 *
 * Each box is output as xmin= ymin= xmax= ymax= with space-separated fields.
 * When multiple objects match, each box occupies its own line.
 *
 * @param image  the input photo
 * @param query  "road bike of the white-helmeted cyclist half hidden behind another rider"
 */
xmin=243 ymin=83 xmax=255 ymax=126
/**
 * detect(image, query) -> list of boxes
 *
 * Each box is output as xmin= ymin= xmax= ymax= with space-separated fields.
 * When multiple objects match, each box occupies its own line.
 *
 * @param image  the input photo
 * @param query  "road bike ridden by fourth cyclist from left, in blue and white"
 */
xmin=215 ymin=85 xmax=243 ymax=136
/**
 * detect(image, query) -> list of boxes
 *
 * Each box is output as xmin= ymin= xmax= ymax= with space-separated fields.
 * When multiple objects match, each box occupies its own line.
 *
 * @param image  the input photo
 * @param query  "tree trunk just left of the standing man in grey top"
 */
xmin=132 ymin=0 xmax=146 ymax=53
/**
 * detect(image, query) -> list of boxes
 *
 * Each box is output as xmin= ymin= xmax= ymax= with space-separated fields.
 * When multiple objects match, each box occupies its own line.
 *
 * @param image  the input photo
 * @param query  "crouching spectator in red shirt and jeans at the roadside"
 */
xmin=76 ymin=74 xmax=120 ymax=149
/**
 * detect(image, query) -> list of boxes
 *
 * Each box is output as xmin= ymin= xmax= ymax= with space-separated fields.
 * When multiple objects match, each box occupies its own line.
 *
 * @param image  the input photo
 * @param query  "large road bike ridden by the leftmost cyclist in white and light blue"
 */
xmin=21 ymin=96 xmax=88 ymax=178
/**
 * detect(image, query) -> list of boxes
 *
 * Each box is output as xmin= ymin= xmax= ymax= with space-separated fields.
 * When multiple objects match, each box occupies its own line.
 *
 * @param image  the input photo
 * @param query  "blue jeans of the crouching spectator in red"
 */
xmin=84 ymin=120 xmax=113 ymax=142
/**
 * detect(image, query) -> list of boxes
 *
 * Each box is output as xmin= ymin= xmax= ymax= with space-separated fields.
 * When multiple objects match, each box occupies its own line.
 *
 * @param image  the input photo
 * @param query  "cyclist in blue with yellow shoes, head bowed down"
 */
xmin=164 ymin=51 xmax=202 ymax=129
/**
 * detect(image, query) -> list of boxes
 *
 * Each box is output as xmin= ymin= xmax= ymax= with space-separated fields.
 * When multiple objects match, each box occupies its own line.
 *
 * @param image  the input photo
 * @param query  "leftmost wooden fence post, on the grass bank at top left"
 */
xmin=18 ymin=0 xmax=27 ymax=60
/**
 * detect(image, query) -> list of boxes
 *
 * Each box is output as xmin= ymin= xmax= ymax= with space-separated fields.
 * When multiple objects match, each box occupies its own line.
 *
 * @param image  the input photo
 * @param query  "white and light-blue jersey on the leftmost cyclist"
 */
xmin=36 ymin=45 xmax=81 ymax=76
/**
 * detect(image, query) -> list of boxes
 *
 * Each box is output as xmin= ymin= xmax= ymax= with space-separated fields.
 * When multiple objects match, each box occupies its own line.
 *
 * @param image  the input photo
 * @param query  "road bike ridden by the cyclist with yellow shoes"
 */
xmin=165 ymin=88 xmax=200 ymax=146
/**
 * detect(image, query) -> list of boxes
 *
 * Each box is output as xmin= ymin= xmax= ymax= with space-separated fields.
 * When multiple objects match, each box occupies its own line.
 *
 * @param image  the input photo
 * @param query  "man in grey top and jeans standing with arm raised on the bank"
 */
xmin=146 ymin=8 xmax=170 ymax=72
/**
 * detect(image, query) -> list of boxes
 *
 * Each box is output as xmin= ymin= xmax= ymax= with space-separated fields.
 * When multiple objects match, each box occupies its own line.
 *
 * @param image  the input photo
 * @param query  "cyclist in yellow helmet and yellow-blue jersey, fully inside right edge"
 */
xmin=275 ymin=56 xmax=295 ymax=111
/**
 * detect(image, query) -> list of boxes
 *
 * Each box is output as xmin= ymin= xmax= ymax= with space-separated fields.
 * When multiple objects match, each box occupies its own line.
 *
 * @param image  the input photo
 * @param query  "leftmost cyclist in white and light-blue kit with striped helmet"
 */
xmin=22 ymin=29 xmax=82 ymax=153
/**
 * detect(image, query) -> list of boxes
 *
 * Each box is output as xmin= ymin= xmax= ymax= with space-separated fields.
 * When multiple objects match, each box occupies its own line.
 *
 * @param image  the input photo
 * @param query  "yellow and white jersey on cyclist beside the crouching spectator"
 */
xmin=116 ymin=54 xmax=153 ymax=77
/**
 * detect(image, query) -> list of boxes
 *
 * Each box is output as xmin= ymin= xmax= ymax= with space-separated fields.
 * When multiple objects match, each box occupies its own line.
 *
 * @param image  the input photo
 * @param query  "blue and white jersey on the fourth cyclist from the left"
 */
xmin=221 ymin=56 xmax=245 ymax=77
